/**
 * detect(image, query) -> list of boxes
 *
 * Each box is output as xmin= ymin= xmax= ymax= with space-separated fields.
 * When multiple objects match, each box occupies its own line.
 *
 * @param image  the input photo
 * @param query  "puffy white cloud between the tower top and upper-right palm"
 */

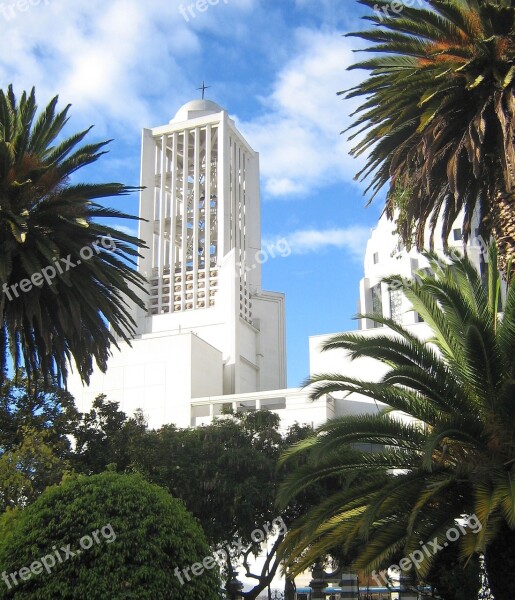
xmin=239 ymin=29 xmax=368 ymax=196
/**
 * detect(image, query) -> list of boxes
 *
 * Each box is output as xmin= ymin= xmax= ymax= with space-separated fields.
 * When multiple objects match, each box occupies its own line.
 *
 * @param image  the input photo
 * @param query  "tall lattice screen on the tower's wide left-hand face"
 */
xmin=149 ymin=125 xmax=222 ymax=314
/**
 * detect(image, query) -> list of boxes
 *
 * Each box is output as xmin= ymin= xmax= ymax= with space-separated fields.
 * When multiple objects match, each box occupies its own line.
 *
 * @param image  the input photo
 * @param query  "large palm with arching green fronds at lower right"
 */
xmin=279 ymin=245 xmax=515 ymax=600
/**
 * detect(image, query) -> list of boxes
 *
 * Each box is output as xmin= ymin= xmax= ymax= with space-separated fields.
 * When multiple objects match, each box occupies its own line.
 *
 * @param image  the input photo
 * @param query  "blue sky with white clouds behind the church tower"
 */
xmin=0 ymin=0 xmax=388 ymax=386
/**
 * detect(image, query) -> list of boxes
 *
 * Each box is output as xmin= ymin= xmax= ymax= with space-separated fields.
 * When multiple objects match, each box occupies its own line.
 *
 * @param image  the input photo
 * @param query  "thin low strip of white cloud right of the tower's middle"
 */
xmin=262 ymin=225 xmax=370 ymax=260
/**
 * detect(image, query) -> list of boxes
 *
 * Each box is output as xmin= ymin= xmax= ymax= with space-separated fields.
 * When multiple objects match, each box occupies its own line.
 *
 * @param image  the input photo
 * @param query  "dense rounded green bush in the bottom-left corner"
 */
xmin=0 ymin=472 xmax=220 ymax=600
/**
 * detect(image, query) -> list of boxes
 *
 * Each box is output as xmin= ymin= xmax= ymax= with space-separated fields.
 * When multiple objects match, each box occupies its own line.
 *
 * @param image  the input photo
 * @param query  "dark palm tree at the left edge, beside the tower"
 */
xmin=0 ymin=86 xmax=144 ymax=382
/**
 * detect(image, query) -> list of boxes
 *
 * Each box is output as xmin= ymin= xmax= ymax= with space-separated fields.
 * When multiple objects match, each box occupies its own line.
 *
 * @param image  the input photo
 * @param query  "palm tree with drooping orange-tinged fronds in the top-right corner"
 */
xmin=340 ymin=0 xmax=515 ymax=270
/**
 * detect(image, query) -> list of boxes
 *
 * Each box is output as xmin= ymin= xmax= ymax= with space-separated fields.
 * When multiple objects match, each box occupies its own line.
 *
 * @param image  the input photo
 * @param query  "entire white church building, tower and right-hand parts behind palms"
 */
xmin=69 ymin=99 xmax=482 ymax=436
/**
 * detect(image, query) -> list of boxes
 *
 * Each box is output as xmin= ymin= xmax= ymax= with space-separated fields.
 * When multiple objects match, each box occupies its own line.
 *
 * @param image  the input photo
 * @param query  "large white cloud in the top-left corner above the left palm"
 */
xmin=0 ymin=0 xmax=201 ymax=139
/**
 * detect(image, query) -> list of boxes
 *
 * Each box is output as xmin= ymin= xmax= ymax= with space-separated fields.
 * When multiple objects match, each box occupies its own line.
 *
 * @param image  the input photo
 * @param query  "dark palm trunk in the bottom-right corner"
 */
xmin=485 ymin=522 xmax=515 ymax=600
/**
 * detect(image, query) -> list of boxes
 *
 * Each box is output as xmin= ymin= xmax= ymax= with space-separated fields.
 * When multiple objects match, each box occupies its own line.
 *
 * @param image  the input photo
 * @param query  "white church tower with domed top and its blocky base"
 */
xmin=69 ymin=100 xmax=286 ymax=427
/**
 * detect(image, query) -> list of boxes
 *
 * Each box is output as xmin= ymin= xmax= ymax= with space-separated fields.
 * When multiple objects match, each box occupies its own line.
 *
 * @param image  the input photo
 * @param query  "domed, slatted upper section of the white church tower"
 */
xmin=139 ymin=100 xmax=261 ymax=329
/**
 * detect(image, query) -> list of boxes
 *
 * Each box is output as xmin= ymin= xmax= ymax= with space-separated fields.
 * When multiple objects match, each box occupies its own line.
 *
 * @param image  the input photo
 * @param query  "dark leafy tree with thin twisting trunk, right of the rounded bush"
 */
xmin=130 ymin=411 xmax=323 ymax=600
